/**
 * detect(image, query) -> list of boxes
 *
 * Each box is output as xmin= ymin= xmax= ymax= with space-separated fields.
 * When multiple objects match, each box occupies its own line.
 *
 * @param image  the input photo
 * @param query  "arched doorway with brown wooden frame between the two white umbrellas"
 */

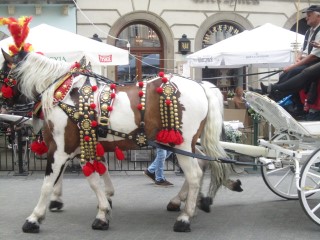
xmin=116 ymin=22 xmax=164 ymax=82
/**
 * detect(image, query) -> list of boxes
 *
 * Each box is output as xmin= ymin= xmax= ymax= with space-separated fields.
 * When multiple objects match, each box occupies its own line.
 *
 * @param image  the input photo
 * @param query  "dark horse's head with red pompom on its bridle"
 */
xmin=0 ymin=50 xmax=30 ymax=113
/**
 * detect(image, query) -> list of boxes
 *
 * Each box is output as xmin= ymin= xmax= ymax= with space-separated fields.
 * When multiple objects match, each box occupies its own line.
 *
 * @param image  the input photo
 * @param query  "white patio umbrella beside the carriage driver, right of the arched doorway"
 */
xmin=187 ymin=23 xmax=304 ymax=68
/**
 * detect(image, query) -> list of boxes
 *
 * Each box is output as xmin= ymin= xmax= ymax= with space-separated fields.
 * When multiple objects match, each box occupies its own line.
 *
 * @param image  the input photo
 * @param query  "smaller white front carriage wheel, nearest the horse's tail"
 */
xmin=261 ymin=133 xmax=298 ymax=200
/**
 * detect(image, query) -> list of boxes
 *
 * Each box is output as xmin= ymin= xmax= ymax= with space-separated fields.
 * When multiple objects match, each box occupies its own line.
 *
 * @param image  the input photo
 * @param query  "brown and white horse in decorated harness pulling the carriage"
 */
xmin=1 ymin=50 xmax=238 ymax=232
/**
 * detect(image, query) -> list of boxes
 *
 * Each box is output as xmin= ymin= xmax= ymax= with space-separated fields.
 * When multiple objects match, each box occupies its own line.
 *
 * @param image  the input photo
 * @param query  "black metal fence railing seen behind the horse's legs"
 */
xmin=0 ymin=126 xmax=178 ymax=175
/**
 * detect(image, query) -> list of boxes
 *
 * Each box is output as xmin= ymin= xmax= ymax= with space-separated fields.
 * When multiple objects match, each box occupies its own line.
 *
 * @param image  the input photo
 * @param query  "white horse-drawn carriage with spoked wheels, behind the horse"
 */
xmin=223 ymin=92 xmax=320 ymax=225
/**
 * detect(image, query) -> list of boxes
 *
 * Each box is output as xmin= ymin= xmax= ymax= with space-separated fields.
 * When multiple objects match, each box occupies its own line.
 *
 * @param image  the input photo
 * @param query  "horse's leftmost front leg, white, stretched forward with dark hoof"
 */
xmin=22 ymin=148 xmax=68 ymax=233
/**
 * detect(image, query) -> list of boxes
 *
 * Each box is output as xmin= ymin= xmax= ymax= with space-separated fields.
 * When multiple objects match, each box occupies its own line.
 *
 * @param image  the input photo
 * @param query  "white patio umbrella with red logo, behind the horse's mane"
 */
xmin=0 ymin=24 xmax=129 ymax=66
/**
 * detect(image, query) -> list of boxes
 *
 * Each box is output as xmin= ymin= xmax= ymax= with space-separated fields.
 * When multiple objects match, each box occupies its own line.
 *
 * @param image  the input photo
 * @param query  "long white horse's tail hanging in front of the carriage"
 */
xmin=201 ymin=83 xmax=231 ymax=198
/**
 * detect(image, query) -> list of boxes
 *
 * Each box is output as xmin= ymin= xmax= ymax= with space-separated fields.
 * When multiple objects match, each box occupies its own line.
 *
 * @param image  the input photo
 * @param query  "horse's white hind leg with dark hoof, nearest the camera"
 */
xmin=173 ymin=155 xmax=203 ymax=232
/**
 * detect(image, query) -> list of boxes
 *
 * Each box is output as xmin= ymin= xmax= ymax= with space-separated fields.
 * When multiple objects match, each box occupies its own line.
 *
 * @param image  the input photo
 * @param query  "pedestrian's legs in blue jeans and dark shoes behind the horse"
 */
xmin=143 ymin=148 xmax=173 ymax=187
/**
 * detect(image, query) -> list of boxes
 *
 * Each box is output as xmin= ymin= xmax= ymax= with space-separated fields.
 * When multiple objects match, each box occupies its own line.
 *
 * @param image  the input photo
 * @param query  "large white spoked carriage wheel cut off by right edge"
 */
xmin=299 ymin=149 xmax=320 ymax=225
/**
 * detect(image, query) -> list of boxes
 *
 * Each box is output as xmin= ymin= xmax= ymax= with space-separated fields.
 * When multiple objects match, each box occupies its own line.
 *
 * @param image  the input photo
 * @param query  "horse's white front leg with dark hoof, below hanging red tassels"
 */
xmin=87 ymin=169 xmax=111 ymax=230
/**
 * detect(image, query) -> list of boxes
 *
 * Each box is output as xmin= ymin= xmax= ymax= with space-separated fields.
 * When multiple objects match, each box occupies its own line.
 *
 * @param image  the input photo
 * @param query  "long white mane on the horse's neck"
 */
xmin=12 ymin=53 xmax=72 ymax=118
